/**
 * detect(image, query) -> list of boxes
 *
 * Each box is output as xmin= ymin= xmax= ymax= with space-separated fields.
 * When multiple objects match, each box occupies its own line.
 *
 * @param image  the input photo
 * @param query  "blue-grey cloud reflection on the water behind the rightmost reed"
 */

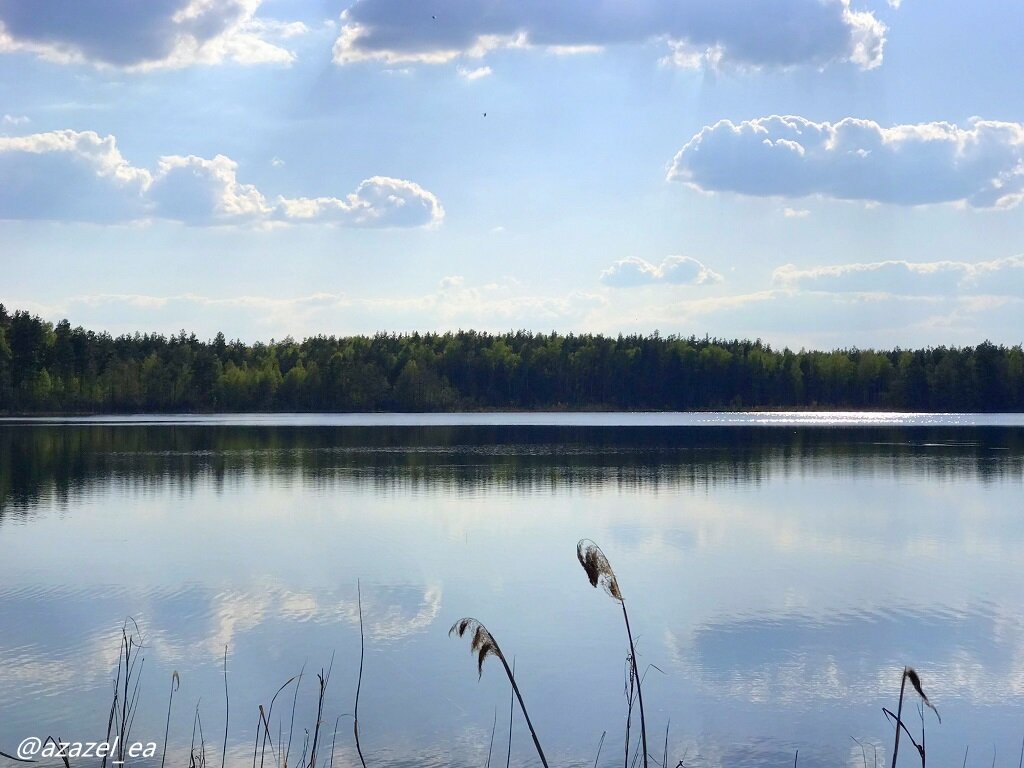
xmin=667 ymin=602 xmax=1024 ymax=707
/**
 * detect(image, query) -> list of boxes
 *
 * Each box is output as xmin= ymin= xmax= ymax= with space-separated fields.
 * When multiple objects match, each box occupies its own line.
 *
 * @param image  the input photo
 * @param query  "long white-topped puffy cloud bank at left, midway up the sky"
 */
xmin=0 ymin=130 xmax=444 ymax=227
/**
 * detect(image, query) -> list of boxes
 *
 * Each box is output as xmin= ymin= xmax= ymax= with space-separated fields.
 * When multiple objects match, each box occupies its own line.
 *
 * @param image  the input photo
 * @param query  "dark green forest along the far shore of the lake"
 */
xmin=0 ymin=304 xmax=1024 ymax=415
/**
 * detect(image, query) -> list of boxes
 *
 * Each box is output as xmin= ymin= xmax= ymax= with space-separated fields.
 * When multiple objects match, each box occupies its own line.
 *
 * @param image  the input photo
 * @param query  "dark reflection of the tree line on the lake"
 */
xmin=0 ymin=425 xmax=1024 ymax=522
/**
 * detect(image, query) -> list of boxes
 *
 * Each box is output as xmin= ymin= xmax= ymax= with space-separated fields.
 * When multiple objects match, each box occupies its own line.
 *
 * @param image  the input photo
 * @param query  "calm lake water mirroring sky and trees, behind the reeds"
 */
xmin=0 ymin=414 xmax=1024 ymax=767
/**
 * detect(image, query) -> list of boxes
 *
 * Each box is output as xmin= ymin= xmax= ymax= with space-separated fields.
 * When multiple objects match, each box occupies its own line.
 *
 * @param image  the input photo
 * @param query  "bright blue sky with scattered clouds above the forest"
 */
xmin=0 ymin=0 xmax=1024 ymax=348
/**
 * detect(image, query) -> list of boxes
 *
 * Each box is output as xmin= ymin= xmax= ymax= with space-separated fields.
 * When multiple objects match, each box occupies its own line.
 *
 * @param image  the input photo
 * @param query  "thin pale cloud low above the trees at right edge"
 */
xmin=772 ymin=256 xmax=1024 ymax=296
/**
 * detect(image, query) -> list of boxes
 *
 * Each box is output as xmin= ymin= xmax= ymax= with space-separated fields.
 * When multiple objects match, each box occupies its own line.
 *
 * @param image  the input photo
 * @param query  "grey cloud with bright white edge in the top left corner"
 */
xmin=0 ymin=0 xmax=306 ymax=70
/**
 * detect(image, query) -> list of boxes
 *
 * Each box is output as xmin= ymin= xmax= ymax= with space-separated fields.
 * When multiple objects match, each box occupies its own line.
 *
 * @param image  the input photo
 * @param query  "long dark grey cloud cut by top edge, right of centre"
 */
xmin=334 ymin=0 xmax=886 ymax=69
